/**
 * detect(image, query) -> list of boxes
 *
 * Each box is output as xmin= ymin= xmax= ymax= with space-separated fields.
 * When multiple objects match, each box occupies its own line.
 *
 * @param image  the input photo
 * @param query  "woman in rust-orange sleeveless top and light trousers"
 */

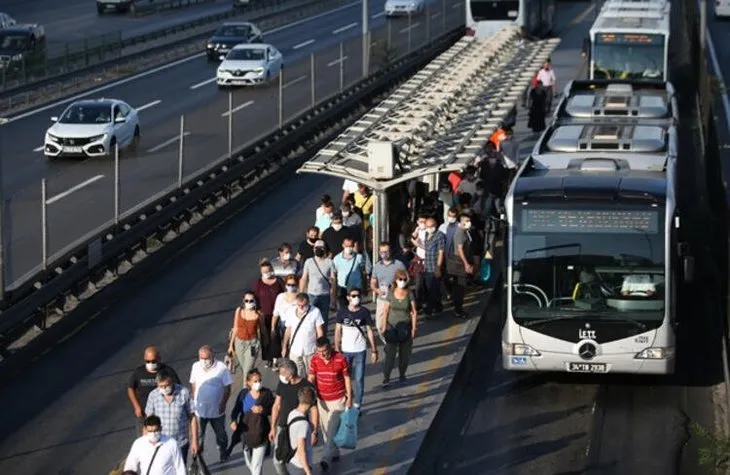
xmin=228 ymin=291 xmax=268 ymax=374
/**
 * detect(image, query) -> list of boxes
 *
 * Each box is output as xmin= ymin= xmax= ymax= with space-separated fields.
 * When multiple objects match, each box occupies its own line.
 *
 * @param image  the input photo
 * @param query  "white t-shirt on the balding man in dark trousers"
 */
xmin=190 ymin=360 xmax=233 ymax=419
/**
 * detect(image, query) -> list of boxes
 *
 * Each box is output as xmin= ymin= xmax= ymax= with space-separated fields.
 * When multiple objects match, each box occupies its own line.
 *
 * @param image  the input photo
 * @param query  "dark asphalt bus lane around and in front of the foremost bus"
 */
xmin=410 ymin=2 xmax=723 ymax=475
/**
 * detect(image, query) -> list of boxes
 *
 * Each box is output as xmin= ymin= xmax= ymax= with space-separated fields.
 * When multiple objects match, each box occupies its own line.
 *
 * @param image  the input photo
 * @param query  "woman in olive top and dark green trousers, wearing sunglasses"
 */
xmin=379 ymin=270 xmax=418 ymax=387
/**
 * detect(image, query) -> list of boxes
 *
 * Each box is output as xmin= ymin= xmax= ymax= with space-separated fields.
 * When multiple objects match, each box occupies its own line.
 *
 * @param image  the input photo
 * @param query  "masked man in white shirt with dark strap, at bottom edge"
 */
xmin=124 ymin=416 xmax=187 ymax=475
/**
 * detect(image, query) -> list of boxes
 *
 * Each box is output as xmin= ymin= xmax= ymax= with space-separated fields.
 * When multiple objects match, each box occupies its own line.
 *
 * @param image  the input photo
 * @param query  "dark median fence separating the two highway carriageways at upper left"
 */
xmin=0 ymin=0 xmax=324 ymax=96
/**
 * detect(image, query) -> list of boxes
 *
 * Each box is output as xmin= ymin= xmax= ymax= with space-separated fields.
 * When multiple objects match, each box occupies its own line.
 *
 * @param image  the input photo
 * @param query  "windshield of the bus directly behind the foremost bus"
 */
xmin=592 ymin=34 xmax=666 ymax=80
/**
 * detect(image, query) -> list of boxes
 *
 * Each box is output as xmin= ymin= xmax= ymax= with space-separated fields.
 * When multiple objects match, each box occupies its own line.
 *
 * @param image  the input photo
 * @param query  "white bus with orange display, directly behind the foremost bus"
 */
xmin=583 ymin=0 xmax=671 ymax=81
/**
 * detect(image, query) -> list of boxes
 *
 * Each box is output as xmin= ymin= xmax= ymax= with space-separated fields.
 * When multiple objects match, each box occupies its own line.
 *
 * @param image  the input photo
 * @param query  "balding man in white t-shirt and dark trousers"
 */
xmin=190 ymin=345 xmax=233 ymax=462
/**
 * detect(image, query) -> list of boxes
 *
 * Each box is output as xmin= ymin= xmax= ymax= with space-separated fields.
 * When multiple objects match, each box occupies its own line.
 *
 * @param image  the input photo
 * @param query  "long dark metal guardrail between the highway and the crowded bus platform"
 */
xmin=0 ymin=26 xmax=464 ymax=369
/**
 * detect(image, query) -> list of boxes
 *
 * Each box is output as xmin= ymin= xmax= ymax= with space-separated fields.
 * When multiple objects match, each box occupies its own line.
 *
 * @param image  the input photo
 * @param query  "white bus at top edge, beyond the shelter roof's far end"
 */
xmin=465 ymin=0 xmax=556 ymax=38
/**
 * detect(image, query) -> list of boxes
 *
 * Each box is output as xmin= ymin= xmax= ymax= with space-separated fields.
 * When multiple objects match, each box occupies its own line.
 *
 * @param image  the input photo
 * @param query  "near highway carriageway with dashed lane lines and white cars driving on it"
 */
xmin=2 ymin=0 xmax=464 ymax=281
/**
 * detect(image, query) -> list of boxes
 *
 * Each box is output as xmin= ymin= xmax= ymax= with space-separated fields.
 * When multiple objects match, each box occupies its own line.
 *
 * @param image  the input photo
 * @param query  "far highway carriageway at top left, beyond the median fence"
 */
xmin=0 ymin=0 xmax=247 ymax=48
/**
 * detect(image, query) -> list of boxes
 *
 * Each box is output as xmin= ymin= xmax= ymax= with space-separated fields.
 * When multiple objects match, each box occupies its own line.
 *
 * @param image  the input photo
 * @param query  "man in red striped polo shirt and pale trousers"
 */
xmin=309 ymin=337 xmax=352 ymax=472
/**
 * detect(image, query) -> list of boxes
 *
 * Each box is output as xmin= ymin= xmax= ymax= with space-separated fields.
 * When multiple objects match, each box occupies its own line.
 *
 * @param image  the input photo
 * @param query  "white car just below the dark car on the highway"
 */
xmin=216 ymin=43 xmax=284 ymax=88
